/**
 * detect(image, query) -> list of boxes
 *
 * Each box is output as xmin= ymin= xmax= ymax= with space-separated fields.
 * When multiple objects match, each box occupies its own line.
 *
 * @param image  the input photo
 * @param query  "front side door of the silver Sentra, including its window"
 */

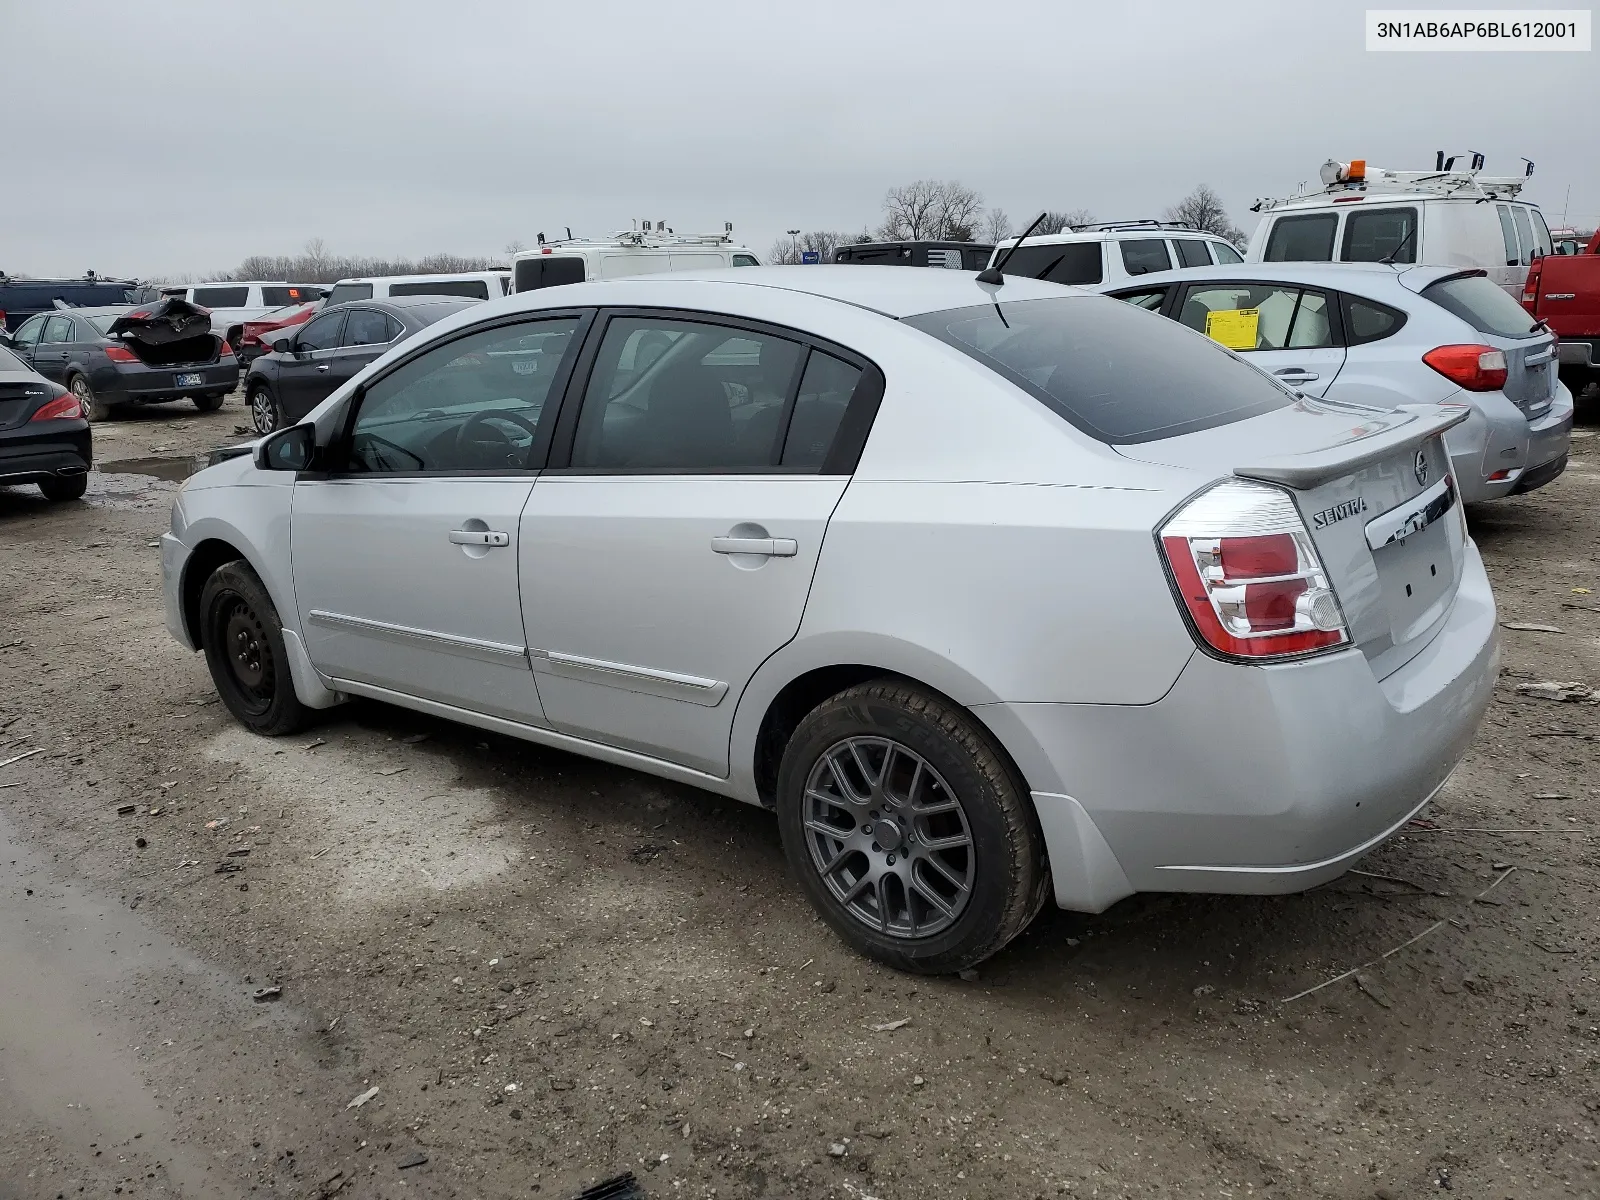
xmin=290 ymin=312 xmax=587 ymax=723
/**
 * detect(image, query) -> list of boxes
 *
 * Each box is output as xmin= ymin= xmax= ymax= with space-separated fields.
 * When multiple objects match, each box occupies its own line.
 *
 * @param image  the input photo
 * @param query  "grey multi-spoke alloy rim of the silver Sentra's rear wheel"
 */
xmin=803 ymin=738 xmax=976 ymax=938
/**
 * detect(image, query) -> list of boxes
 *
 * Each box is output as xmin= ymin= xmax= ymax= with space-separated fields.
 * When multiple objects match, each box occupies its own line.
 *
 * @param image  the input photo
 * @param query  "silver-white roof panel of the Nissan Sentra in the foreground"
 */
xmin=601 ymin=262 xmax=1091 ymax=318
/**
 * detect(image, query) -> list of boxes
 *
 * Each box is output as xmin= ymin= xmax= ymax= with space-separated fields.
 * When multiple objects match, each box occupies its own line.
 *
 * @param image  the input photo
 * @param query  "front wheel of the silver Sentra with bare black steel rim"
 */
xmin=200 ymin=558 xmax=310 ymax=738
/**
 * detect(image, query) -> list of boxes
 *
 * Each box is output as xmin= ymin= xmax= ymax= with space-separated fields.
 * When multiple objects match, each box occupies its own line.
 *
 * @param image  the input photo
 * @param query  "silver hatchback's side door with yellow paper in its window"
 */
xmin=1173 ymin=280 xmax=1344 ymax=395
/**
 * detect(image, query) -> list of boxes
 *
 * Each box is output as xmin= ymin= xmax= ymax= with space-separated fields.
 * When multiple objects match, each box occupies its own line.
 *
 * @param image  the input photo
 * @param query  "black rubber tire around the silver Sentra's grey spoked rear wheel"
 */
xmin=778 ymin=680 xmax=1050 ymax=974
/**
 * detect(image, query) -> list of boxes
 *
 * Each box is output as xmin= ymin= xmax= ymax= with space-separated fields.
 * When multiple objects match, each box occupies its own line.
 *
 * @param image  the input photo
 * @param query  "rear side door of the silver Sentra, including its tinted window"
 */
xmin=520 ymin=310 xmax=882 ymax=776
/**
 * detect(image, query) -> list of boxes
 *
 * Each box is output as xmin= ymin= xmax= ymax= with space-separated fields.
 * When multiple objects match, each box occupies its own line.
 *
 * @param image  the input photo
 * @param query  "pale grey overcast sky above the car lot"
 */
xmin=0 ymin=0 xmax=1600 ymax=277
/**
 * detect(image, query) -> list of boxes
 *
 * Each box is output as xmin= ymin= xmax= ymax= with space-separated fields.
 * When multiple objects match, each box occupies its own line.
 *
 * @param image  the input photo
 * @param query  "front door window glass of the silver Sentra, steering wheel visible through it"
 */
xmin=349 ymin=317 xmax=578 ymax=472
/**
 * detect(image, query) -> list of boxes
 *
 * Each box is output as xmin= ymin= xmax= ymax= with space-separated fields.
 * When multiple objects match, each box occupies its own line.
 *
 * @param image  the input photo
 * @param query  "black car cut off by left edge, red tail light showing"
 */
xmin=0 ymin=346 xmax=94 ymax=499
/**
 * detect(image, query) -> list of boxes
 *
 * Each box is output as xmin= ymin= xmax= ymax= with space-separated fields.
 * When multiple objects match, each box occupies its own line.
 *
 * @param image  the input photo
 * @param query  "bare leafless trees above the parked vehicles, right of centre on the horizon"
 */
xmin=766 ymin=179 xmax=1245 ymax=264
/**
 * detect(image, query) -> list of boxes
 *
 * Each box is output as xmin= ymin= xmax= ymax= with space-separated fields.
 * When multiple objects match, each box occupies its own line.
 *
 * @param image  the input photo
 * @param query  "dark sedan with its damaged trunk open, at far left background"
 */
xmin=2 ymin=298 xmax=240 ymax=421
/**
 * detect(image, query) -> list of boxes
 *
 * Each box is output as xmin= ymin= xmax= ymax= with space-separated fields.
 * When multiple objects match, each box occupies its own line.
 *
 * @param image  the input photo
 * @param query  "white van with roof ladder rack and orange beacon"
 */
xmin=1245 ymin=154 xmax=1550 ymax=298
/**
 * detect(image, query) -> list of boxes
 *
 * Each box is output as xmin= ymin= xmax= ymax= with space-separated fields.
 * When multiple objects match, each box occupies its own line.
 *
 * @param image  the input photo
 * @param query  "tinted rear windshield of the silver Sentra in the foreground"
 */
xmin=906 ymin=296 xmax=1294 ymax=445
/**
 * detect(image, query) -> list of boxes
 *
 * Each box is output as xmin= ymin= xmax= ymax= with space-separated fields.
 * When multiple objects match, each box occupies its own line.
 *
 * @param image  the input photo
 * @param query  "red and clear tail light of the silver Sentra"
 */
xmin=1160 ymin=480 xmax=1350 ymax=662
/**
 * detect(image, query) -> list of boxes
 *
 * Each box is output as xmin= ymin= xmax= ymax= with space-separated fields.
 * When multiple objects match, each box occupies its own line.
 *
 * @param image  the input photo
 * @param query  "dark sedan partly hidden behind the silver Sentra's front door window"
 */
xmin=245 ymin=296 xmax=480 ymax=434
